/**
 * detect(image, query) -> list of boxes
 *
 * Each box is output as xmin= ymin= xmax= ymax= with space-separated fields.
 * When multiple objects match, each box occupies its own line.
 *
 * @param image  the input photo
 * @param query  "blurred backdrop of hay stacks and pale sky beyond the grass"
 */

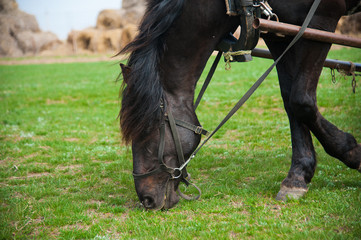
xmin=0 ymin=0 xmax=361 ymax=57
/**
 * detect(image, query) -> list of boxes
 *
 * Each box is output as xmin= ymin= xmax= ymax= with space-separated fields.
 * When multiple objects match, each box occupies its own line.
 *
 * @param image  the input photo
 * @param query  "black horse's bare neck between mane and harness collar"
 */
xmin=159 ymin=0 xmax=238 ymax=113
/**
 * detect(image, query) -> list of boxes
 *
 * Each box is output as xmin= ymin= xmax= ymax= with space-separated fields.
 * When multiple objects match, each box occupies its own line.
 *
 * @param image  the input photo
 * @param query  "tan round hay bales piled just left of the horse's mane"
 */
xmin=67 ymin=0 xmax=145 ymax=53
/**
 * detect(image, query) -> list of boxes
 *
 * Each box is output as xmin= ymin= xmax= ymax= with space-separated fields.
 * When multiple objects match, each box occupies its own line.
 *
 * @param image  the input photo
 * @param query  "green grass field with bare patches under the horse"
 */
xmin=0 ymin=49 xmax=361 ymax=239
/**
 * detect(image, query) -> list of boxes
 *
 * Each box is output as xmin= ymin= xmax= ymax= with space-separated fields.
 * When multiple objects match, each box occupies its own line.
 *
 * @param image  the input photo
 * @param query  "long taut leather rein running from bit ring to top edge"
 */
xmin=191 ymin=0 xmax=321 ymax=162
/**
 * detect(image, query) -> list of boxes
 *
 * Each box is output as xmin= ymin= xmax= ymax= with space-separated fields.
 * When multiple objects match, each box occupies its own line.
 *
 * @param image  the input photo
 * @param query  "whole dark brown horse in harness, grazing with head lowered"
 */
xmin=119 ymin=0 xmax=361 ymax=210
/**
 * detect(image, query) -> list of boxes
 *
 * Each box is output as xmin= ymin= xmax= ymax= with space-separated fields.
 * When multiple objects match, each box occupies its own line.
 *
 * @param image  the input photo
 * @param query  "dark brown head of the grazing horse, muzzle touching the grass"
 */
xmin=120 ymin=61 xmax=204 ymax=210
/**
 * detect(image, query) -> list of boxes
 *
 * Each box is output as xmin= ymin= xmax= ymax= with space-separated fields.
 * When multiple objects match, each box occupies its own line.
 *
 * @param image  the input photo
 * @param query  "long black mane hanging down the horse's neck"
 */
xmin=118 ymin=0 xmax=185 ymax=144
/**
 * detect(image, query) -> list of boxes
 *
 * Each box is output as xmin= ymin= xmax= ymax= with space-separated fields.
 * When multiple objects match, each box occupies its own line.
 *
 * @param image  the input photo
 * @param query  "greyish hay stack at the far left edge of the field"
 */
xmin=0 ymin=0 xmax=61 ymax=57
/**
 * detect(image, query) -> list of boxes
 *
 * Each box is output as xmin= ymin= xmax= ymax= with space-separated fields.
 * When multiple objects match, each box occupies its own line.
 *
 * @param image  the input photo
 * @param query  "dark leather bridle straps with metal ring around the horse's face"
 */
xmin=133 ymin=99 xmax=209 ymax=186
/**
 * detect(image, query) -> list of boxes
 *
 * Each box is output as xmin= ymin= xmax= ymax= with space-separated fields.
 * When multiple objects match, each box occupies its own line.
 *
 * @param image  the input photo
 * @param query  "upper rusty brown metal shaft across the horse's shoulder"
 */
xmin=253 ymin=18 xmax=361 ymax=48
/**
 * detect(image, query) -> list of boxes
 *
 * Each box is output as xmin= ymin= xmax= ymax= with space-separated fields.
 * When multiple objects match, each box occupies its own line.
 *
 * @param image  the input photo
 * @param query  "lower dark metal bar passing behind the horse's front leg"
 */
xmin=252 ymin=48 xmax=361 ymax=72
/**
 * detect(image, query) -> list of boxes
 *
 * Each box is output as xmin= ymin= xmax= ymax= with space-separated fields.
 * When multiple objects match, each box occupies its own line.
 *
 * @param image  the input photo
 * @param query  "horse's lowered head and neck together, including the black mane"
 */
xmin=119 ymin=0 xmax=238 ymax=209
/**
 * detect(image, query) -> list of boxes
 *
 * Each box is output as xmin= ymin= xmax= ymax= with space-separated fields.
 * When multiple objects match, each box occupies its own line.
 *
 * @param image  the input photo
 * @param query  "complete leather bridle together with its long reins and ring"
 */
xmin=133 ymin=0 xmax=321 ymax=200
